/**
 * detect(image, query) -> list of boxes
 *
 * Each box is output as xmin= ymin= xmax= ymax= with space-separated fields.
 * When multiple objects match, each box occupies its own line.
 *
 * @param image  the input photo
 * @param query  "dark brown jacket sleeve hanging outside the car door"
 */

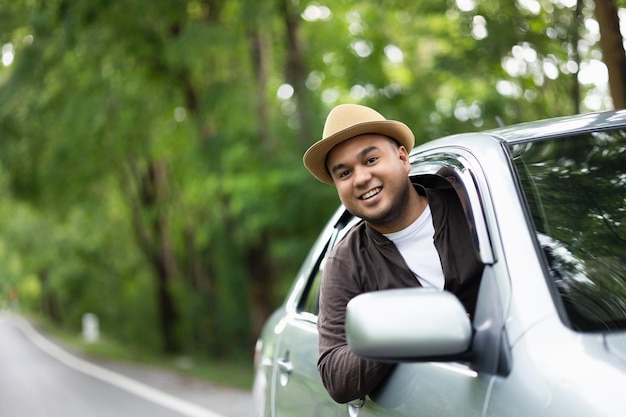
xmin=317 ymin=256 xmax=394 ymax=403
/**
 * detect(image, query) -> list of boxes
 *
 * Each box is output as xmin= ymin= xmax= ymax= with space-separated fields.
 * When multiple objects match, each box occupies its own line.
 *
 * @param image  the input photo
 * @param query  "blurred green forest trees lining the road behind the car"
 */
xmin=0 ymin=0 xmax=626 ymax=386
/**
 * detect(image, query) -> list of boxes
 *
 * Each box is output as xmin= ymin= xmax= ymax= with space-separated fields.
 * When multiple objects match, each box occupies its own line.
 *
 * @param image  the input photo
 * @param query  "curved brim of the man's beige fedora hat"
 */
xmin=302 ymin=120 xmax=415 ymax=184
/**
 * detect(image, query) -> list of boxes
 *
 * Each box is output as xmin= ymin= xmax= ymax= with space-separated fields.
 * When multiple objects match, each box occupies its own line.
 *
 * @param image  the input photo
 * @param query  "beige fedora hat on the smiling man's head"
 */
xmin=302 ymin=104 xmax=415 ymax=184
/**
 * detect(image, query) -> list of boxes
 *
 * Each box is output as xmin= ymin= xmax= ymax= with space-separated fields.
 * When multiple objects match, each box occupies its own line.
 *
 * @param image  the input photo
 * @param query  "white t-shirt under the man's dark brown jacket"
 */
xmin=385 ymin=206 xmax=445 ymax=290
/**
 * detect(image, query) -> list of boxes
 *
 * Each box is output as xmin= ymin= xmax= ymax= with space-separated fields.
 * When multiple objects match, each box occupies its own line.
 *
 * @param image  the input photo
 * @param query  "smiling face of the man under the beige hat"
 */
xmin=326 ymin=134 xmax=411 ymax=233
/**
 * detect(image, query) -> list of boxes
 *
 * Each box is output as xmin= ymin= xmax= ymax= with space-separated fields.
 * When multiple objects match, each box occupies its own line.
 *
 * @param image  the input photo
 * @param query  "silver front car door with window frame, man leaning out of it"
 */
xmin=353 ymin=148 xmax=504 ymax=417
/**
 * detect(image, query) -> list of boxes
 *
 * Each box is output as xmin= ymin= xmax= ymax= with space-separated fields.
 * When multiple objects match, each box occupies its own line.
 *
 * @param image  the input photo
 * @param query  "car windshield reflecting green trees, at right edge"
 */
xmin=509 ymin=130 xmax=626 ymax=331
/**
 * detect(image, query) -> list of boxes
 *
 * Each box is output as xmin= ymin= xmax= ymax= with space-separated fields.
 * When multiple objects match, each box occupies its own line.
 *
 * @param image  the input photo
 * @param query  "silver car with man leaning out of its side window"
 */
xmin=253 ymin=111 xmax=626 ymax=417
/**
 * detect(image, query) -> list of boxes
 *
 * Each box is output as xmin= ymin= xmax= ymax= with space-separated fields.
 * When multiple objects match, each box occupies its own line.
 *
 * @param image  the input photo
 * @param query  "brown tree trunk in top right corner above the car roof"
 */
xmin=595 ymin=0 xmax=626 ymax=109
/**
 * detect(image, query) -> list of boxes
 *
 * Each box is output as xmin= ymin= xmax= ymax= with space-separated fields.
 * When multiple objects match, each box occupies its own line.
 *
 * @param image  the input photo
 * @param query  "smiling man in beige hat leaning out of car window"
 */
xmin=303 ymin=104 xmax=482 ymax=403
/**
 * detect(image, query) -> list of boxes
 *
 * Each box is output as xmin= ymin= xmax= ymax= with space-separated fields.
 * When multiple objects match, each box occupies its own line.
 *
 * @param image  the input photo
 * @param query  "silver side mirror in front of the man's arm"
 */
xmin=346 ymin=288 xmax=472 ymax=361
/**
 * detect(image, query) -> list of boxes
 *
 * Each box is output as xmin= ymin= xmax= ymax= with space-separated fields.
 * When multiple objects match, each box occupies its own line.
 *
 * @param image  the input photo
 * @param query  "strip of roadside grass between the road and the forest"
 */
xmin=28 ymin=317 xmax=254 ymax=390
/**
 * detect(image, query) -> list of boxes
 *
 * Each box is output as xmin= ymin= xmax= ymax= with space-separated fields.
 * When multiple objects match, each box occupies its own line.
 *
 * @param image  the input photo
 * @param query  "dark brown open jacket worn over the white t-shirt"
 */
xmin=317 ymin=184 xmax=483 ymax=403
